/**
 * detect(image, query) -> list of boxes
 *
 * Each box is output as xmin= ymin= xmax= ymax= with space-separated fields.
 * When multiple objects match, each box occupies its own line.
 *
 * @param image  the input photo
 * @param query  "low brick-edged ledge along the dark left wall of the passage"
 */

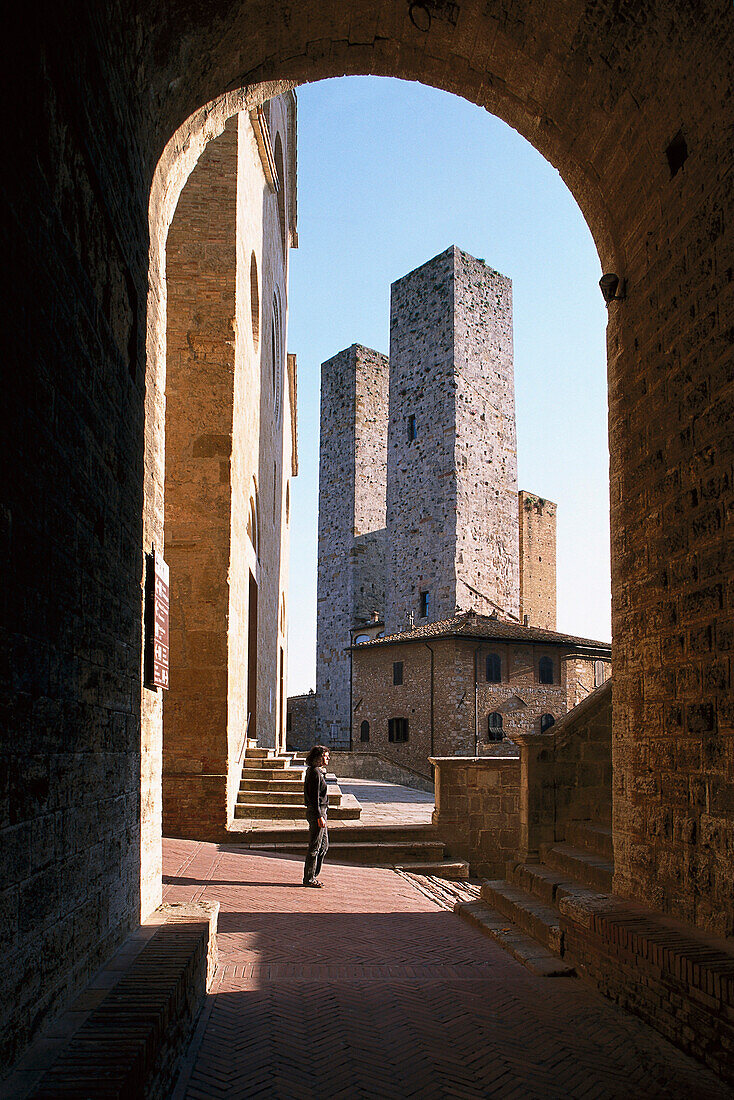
xmin=5 ymin=902 xmax=219 ymax=1100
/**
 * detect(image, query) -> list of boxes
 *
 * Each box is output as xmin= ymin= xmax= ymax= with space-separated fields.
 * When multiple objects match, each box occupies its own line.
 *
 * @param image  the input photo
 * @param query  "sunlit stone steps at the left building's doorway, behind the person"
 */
xmin=234 ymin=743 xmax=362 ymax=822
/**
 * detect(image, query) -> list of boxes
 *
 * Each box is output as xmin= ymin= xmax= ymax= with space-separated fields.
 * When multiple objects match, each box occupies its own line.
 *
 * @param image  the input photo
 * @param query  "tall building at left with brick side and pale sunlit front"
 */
xmin=163 ymin=95 xmax=296 ymax=836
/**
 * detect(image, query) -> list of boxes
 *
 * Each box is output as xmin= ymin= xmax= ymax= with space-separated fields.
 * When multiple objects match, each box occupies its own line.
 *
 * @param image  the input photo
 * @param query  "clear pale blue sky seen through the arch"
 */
xmin=288 ymin=77 xmax=611 ymax=694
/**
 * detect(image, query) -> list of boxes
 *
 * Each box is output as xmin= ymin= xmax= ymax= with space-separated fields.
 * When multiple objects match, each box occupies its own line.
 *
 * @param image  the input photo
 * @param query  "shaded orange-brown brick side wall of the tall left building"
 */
xmin=163 ymin=118 xmax=238 ymax=835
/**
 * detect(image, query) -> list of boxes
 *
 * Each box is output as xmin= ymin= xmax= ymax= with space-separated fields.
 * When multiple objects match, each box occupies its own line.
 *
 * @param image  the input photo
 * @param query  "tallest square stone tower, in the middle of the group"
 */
xmin=385 ymin=246 xmax=519 ymax=634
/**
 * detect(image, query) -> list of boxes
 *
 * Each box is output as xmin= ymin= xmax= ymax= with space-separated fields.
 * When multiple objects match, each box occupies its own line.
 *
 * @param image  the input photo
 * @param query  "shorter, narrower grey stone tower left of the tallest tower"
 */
xmin=316 ymin=344 xmax=388 ymax=741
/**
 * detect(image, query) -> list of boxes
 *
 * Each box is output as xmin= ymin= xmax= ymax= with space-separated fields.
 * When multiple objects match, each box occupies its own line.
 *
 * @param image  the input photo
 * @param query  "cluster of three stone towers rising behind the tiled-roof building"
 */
xmin=316 ymin=246 xmax=556 ymax=743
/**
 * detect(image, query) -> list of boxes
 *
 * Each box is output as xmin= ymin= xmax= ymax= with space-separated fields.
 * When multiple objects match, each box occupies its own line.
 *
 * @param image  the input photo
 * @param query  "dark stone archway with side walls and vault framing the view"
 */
xmin=0 ymin=0 xmax=734 ymax=1064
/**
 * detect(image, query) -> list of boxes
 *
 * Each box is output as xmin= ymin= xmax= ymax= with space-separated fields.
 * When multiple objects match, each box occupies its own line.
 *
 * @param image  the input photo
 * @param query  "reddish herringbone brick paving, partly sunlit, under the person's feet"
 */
xmin=164 ymin=840 xmax=731 ymax=1100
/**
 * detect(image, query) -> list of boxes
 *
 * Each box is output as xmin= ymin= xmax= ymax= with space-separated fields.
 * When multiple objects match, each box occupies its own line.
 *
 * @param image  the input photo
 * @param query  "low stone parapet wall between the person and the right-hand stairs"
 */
xmin=430 ymin=757 xmax=521 ymax=878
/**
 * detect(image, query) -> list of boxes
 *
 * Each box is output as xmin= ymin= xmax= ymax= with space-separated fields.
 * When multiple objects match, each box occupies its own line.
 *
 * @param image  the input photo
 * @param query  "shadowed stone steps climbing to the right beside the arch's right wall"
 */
xmin=456 ymin=822 xmax=614 ymax=977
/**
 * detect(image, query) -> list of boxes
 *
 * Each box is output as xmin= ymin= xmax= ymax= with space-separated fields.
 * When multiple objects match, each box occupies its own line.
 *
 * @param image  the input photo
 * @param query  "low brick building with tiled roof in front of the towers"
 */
xmin=351 ymin=612 xmax=612 ymax=778
